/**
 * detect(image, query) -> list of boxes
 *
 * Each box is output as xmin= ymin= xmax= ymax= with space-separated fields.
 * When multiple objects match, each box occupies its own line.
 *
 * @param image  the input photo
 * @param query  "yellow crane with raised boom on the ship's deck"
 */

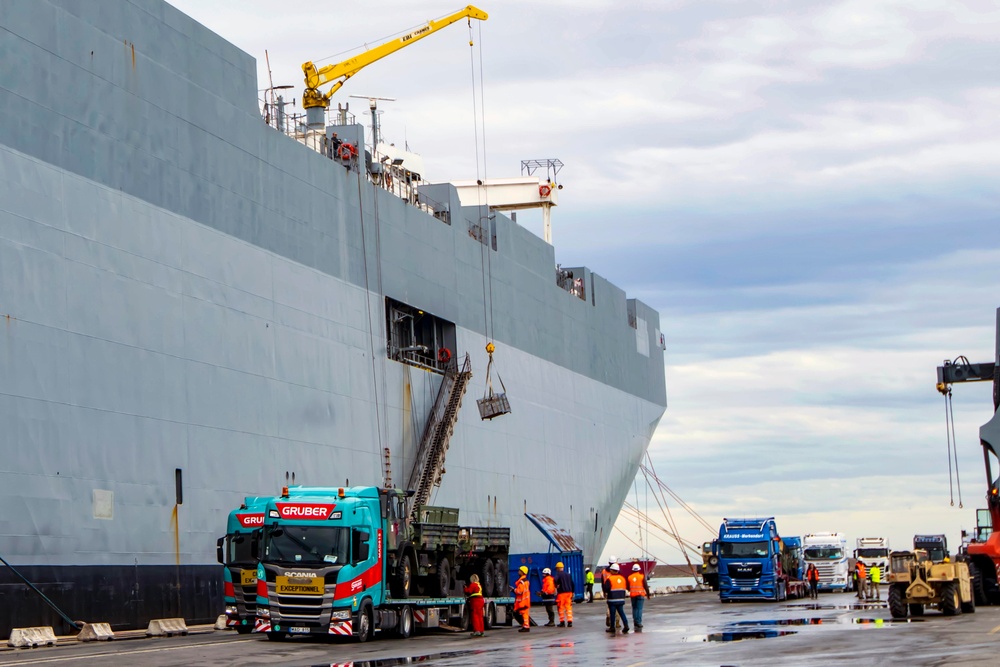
xmin=302 ymin=5 xmax=489 ymax=109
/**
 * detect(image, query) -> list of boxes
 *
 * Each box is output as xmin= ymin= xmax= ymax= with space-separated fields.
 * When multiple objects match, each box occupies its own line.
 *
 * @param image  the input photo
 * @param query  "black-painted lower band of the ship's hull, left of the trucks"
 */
xmin=0 ymin=565 xmax=224 ymax=637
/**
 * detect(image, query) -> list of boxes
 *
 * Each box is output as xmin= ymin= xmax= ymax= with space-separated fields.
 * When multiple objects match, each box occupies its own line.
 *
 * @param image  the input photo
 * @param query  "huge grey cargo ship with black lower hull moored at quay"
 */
xmin=0 ymin=0 xmax=666 ymax=636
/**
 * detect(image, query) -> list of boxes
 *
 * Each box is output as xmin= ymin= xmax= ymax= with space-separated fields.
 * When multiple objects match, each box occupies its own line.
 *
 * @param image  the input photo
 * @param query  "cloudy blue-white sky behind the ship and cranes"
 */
xmin=172 ymin=0 xmax=1000 ymax=562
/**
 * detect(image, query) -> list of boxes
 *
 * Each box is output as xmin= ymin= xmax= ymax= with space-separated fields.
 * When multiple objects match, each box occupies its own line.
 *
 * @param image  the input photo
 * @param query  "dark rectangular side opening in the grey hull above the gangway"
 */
xmin=385 ymin=298 xmax=457 ymax=373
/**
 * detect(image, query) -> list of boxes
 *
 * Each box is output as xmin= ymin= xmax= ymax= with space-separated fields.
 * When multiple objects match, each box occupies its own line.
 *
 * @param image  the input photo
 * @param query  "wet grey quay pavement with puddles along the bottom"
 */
xmin=0 ymin=593 xmax=1000 ymax=667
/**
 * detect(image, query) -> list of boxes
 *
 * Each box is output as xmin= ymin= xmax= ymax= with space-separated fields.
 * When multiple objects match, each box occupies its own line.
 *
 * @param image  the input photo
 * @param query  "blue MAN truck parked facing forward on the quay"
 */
xmin=716 ymin=517 xmax=806 ymax=602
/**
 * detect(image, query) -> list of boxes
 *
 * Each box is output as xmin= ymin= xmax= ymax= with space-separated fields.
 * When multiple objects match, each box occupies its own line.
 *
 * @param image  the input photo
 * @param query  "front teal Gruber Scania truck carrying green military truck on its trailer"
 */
xmin=254 ymin=486 xmax=513 ymax=641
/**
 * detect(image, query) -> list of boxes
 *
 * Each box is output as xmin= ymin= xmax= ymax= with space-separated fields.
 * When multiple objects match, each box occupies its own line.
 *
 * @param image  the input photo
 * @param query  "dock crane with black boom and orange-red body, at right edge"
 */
xmin=937 ymin=308 xmax=1000 ymax=605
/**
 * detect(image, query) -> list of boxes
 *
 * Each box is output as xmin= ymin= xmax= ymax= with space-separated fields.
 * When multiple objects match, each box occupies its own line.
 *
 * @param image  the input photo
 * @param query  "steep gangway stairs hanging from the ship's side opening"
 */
xmin=406 ymin=354 xmax=472 ymax=520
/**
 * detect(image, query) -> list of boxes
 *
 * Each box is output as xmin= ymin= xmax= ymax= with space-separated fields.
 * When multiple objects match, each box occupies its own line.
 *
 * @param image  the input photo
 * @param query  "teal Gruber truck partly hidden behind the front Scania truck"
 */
xmin=216 ymin=496 xmax=270 ymax=634
